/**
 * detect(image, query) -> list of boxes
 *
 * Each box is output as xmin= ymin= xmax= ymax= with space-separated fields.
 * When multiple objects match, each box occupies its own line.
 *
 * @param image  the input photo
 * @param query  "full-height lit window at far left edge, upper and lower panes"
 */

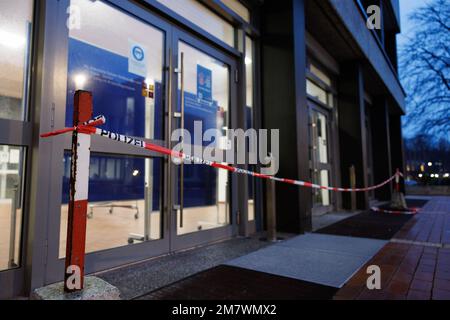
xmin=0 ymin=0 xmax=33 ymax=271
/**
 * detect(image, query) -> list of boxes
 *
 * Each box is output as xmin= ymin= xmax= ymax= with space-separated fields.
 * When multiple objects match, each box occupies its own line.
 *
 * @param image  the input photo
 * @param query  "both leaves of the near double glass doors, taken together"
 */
xmin=44 ymin=0 xmax=236 ymax=283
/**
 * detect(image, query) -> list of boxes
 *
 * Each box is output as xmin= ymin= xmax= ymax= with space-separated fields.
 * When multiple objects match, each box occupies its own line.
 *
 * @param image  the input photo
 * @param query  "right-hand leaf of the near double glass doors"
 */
xmin=171 ymin=33 xmax=235 ymax=250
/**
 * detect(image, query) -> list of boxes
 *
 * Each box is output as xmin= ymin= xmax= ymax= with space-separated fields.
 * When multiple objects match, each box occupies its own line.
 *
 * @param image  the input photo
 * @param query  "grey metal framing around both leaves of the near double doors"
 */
xmin=41 ymin=0 xmax=237 ymax=287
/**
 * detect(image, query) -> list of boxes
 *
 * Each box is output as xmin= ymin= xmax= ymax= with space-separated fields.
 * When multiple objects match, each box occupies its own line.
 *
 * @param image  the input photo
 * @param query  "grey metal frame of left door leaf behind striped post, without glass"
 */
xmin=42 ymin=0 xmax=173 ymax=284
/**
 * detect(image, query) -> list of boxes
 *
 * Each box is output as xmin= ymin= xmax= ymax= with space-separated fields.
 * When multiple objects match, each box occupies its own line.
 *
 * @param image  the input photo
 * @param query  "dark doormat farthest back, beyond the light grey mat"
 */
xmin=315 ymin=211 xmax=413 ymax=240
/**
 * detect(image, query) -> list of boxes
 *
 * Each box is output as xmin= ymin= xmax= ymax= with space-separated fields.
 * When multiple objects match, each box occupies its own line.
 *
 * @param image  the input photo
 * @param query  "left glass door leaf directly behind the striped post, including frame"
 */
xmin=43 ymin=0 xmax=171 ymax=283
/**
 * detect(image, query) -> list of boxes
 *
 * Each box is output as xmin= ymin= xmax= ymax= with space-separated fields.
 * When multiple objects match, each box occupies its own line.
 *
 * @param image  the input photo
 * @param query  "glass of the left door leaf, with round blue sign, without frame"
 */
xmin=59 ymin=0 xmax=165 ymax=257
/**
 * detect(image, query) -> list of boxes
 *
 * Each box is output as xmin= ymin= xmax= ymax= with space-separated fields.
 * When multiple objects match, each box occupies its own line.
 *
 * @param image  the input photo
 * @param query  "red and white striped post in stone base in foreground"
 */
xmin=64 ymin=91 xmax=92 ymax=292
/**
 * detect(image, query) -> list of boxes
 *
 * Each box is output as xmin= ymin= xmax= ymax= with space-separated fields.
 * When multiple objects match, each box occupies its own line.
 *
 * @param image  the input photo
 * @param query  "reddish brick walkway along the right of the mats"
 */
xmin=334 ymin=197 xmax=450 ymax=300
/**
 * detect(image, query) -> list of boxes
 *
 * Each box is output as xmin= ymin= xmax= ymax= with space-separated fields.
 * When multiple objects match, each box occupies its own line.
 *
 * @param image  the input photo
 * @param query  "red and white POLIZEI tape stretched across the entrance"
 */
xmin=41 ymin=116 xmax=403 ymax=192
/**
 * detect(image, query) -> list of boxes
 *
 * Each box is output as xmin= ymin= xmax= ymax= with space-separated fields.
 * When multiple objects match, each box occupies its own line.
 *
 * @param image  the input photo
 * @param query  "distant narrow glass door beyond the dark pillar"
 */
xmin=309 ymin=106 xmax=332 ymax=215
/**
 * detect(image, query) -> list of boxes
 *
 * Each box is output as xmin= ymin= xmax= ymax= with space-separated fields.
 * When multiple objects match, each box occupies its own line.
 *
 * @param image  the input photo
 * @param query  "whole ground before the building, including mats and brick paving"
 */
xmin=99 ymin=197 xmax=450 ymax=300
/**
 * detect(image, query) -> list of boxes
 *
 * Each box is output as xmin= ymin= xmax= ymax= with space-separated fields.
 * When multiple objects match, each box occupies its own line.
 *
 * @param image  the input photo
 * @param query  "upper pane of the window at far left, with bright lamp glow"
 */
xmin=0 ymin=0 xmax=33 ymax=120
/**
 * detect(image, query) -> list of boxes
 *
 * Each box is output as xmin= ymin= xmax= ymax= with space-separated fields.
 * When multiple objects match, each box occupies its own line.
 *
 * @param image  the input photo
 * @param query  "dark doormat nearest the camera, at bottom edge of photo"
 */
xmin=140 ymin=266 xmax=337 ymax=300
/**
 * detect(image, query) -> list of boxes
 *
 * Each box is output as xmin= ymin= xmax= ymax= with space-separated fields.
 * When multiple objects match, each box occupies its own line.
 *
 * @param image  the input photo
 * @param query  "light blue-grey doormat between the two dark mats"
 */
xmin=226 ymin=233 xmax=386 ymax=288
